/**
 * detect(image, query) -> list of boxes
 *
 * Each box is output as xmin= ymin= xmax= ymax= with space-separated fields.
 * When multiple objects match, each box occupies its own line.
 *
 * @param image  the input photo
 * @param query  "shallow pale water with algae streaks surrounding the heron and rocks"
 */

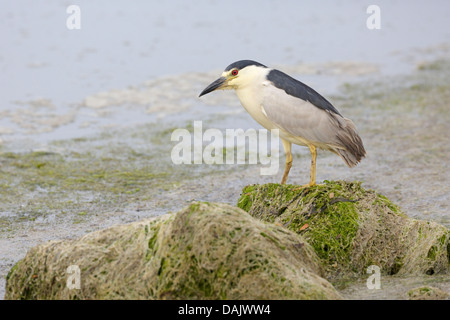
xmin=0 ymin=0 xmax=450 ymax=299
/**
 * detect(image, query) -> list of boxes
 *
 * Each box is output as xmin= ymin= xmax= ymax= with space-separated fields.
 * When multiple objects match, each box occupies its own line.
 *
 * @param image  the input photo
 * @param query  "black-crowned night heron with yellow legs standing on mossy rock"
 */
xmin=200 ymin=60 xmax=366 ymax=186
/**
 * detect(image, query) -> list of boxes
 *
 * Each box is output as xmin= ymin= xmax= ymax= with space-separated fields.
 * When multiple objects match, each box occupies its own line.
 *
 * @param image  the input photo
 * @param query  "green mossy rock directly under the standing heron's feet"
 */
xmin=237 ymin=181 xmax=450 ymax=281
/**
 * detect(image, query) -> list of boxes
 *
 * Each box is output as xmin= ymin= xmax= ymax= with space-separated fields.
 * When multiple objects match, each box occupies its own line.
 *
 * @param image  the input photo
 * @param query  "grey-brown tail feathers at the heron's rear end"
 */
xmin=335 ymin=118 xmax=366 ymax=168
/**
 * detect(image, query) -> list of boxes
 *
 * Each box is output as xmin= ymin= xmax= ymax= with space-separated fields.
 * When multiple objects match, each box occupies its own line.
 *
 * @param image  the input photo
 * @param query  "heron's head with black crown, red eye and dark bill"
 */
xmin=199 ymin=60 xmax=267 ymax=97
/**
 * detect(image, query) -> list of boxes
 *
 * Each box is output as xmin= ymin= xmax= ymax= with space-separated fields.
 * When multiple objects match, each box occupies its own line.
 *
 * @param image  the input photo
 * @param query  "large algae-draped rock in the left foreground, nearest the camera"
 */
xmin=5 ymin=202 xmax=341 ymax=299
